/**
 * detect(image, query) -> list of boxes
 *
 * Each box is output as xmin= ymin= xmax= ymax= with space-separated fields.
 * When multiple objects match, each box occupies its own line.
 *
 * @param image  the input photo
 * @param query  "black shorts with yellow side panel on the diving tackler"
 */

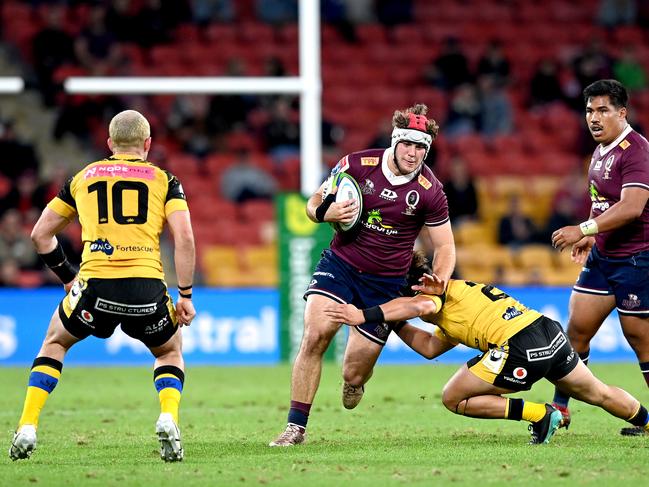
xmin=467 ymin=316 xmax=579 ymax=391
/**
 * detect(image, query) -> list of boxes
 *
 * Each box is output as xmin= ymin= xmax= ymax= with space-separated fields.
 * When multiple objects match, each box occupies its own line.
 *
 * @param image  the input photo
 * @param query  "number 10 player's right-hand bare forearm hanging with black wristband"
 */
xmin=167 ymin=210 xmax=196 ymax=326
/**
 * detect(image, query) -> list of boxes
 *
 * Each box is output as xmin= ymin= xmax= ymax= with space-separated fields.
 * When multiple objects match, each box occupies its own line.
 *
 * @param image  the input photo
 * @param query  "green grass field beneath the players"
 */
xmin=0 ymin=364 xmax=649 ymax=487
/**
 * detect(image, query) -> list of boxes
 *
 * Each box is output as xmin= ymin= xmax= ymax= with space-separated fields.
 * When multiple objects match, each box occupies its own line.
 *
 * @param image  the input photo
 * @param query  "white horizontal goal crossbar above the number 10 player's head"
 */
xmin=63 ymin=76 xmax=302 ymax=95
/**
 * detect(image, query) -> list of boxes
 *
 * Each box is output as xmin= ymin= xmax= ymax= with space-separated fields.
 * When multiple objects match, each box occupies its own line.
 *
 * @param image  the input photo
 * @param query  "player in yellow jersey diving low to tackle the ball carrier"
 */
xmin=326 ymin=252 xmax=649 ymax=444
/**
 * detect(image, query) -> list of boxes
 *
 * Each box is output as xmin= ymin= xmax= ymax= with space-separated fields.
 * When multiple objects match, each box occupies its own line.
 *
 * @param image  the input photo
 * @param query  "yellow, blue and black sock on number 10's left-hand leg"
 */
xmin=18 ymin=357 xmax=63 ymax=428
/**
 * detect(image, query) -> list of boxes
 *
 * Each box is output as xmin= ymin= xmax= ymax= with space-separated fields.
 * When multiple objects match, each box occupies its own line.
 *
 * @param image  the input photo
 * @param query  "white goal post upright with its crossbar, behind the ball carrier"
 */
xmin=63 ymin=0 xmax=322 ymax=196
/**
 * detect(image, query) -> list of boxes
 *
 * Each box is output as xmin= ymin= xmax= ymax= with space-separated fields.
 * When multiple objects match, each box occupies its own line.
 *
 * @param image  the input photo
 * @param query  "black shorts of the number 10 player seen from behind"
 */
xmin=59 ymin=278 xmax=177 ymax=347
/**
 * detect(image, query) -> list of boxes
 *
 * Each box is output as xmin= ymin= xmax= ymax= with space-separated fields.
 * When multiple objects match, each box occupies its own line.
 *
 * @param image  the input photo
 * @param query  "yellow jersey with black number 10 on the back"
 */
xmin=47 ymin=154 xmax=188 ymax=279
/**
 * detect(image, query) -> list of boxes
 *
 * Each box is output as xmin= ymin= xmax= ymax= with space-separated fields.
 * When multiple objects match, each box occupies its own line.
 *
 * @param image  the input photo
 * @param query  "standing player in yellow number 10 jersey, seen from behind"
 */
xmin=9 ymin=110 xmax=196 ymax=461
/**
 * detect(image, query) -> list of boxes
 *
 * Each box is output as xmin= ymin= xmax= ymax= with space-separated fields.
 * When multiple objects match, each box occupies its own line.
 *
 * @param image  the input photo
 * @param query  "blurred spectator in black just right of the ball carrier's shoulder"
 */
xmin=444 ymin=157 xmax=478 ymax=225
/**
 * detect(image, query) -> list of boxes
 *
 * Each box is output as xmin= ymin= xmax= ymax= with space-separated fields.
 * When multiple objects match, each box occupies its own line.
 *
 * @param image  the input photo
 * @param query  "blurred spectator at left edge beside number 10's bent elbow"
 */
xmin=0 ymin=210 xmax=40 ymax=269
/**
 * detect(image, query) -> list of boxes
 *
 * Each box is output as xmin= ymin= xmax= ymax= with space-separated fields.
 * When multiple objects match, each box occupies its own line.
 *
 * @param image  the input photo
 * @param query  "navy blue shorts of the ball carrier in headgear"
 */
xmin=304 ymin=249 xmax=406 ymax=345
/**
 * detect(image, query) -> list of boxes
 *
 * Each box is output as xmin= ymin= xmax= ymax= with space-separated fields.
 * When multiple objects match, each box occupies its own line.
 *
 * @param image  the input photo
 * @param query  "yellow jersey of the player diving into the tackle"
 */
xmin=422 ymin=280 xmax=541 ymax=352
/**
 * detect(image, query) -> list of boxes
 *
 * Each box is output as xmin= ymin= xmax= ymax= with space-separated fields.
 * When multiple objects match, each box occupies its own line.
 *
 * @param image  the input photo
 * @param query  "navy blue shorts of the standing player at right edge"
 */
xmin=573 ymin=246 xmax=649 ymax=318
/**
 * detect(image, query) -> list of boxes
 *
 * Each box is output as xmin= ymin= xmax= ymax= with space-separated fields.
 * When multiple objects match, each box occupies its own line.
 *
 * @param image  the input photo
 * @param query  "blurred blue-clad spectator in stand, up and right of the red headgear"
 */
xmin=478 ymin=75 xmax=514 ymax=137
